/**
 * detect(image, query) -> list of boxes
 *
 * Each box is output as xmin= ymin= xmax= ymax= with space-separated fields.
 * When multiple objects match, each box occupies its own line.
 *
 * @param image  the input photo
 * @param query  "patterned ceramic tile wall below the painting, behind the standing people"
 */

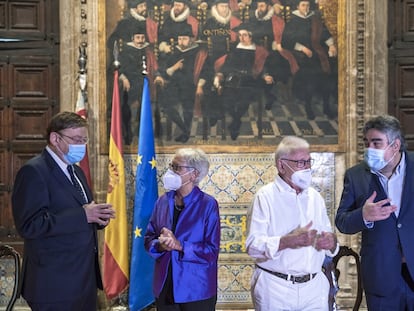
xmin=125 ymin=153 xmax=335 ymax=308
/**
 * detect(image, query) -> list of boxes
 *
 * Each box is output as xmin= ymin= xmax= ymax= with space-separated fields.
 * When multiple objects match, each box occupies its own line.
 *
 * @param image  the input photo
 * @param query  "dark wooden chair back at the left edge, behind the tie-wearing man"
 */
xmin=0 ymin=244 xmax=20 ymax=311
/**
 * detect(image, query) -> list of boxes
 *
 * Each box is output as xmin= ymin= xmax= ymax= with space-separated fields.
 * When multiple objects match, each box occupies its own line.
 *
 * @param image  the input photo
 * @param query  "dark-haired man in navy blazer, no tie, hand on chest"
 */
xmin=335 ymin=115 xmax=414 ymax=311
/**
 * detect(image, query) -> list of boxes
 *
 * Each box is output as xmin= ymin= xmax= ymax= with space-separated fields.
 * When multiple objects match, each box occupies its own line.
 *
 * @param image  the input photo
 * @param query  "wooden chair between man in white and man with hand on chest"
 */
xmin=323 ymin=246 xmax=362 ymax=311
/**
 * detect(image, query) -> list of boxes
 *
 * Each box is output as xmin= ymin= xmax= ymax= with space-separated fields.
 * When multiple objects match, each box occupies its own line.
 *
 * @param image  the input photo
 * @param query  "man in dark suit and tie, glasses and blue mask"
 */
xmin=12 ymin=112 xmax=115 ymax=311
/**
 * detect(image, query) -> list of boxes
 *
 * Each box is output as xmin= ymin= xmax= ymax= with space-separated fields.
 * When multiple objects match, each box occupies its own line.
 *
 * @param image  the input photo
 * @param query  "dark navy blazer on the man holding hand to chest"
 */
xmin=335 ymin=153 xmax=414 ymax=296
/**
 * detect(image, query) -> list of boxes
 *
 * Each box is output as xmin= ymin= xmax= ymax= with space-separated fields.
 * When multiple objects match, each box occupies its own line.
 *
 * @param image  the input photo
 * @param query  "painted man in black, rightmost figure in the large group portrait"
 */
xmin=281 ymin=0 xmax=338 ymax=120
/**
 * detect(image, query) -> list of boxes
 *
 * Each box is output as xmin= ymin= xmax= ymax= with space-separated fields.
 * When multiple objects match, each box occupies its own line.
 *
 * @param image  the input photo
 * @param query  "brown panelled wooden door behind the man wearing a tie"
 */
xmin=0 ymin=0 xmax=59 ymax=249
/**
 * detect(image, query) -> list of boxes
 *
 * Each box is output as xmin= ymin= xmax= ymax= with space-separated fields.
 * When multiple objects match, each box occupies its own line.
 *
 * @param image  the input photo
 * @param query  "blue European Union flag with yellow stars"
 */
xmin=129 ymin=77 xmax=158 ymax=311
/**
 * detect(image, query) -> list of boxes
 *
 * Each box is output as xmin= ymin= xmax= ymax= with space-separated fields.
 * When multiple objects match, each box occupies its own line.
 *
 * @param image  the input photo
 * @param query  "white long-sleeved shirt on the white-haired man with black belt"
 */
xmin=246 ymin=176 xmax=338 ymax=275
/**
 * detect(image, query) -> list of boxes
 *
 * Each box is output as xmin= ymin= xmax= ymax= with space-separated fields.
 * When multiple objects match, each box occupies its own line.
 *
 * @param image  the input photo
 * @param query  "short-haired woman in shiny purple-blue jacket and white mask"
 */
xmin=145 ymin=148 xmax=220 ymax=311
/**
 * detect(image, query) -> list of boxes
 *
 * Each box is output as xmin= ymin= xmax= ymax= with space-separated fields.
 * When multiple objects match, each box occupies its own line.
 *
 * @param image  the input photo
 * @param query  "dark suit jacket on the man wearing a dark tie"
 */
xmin=12 ymin=150 xmax=102 ymax=303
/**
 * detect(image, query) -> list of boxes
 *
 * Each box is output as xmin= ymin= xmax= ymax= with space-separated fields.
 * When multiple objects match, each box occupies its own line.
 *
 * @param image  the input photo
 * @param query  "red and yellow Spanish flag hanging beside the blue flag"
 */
xmin=103 ymin=70 xmax=129 ymax=299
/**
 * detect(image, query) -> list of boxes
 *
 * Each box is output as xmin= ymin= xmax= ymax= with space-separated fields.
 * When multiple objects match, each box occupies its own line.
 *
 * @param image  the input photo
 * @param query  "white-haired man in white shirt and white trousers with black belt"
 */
xmin=246 ymin=136 xmax=339 ymax=311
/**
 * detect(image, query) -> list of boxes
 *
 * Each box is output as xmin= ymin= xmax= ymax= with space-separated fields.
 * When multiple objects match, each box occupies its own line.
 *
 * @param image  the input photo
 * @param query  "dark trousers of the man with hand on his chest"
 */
xmin=366 ymin=264 xmax=414 ymax=311
